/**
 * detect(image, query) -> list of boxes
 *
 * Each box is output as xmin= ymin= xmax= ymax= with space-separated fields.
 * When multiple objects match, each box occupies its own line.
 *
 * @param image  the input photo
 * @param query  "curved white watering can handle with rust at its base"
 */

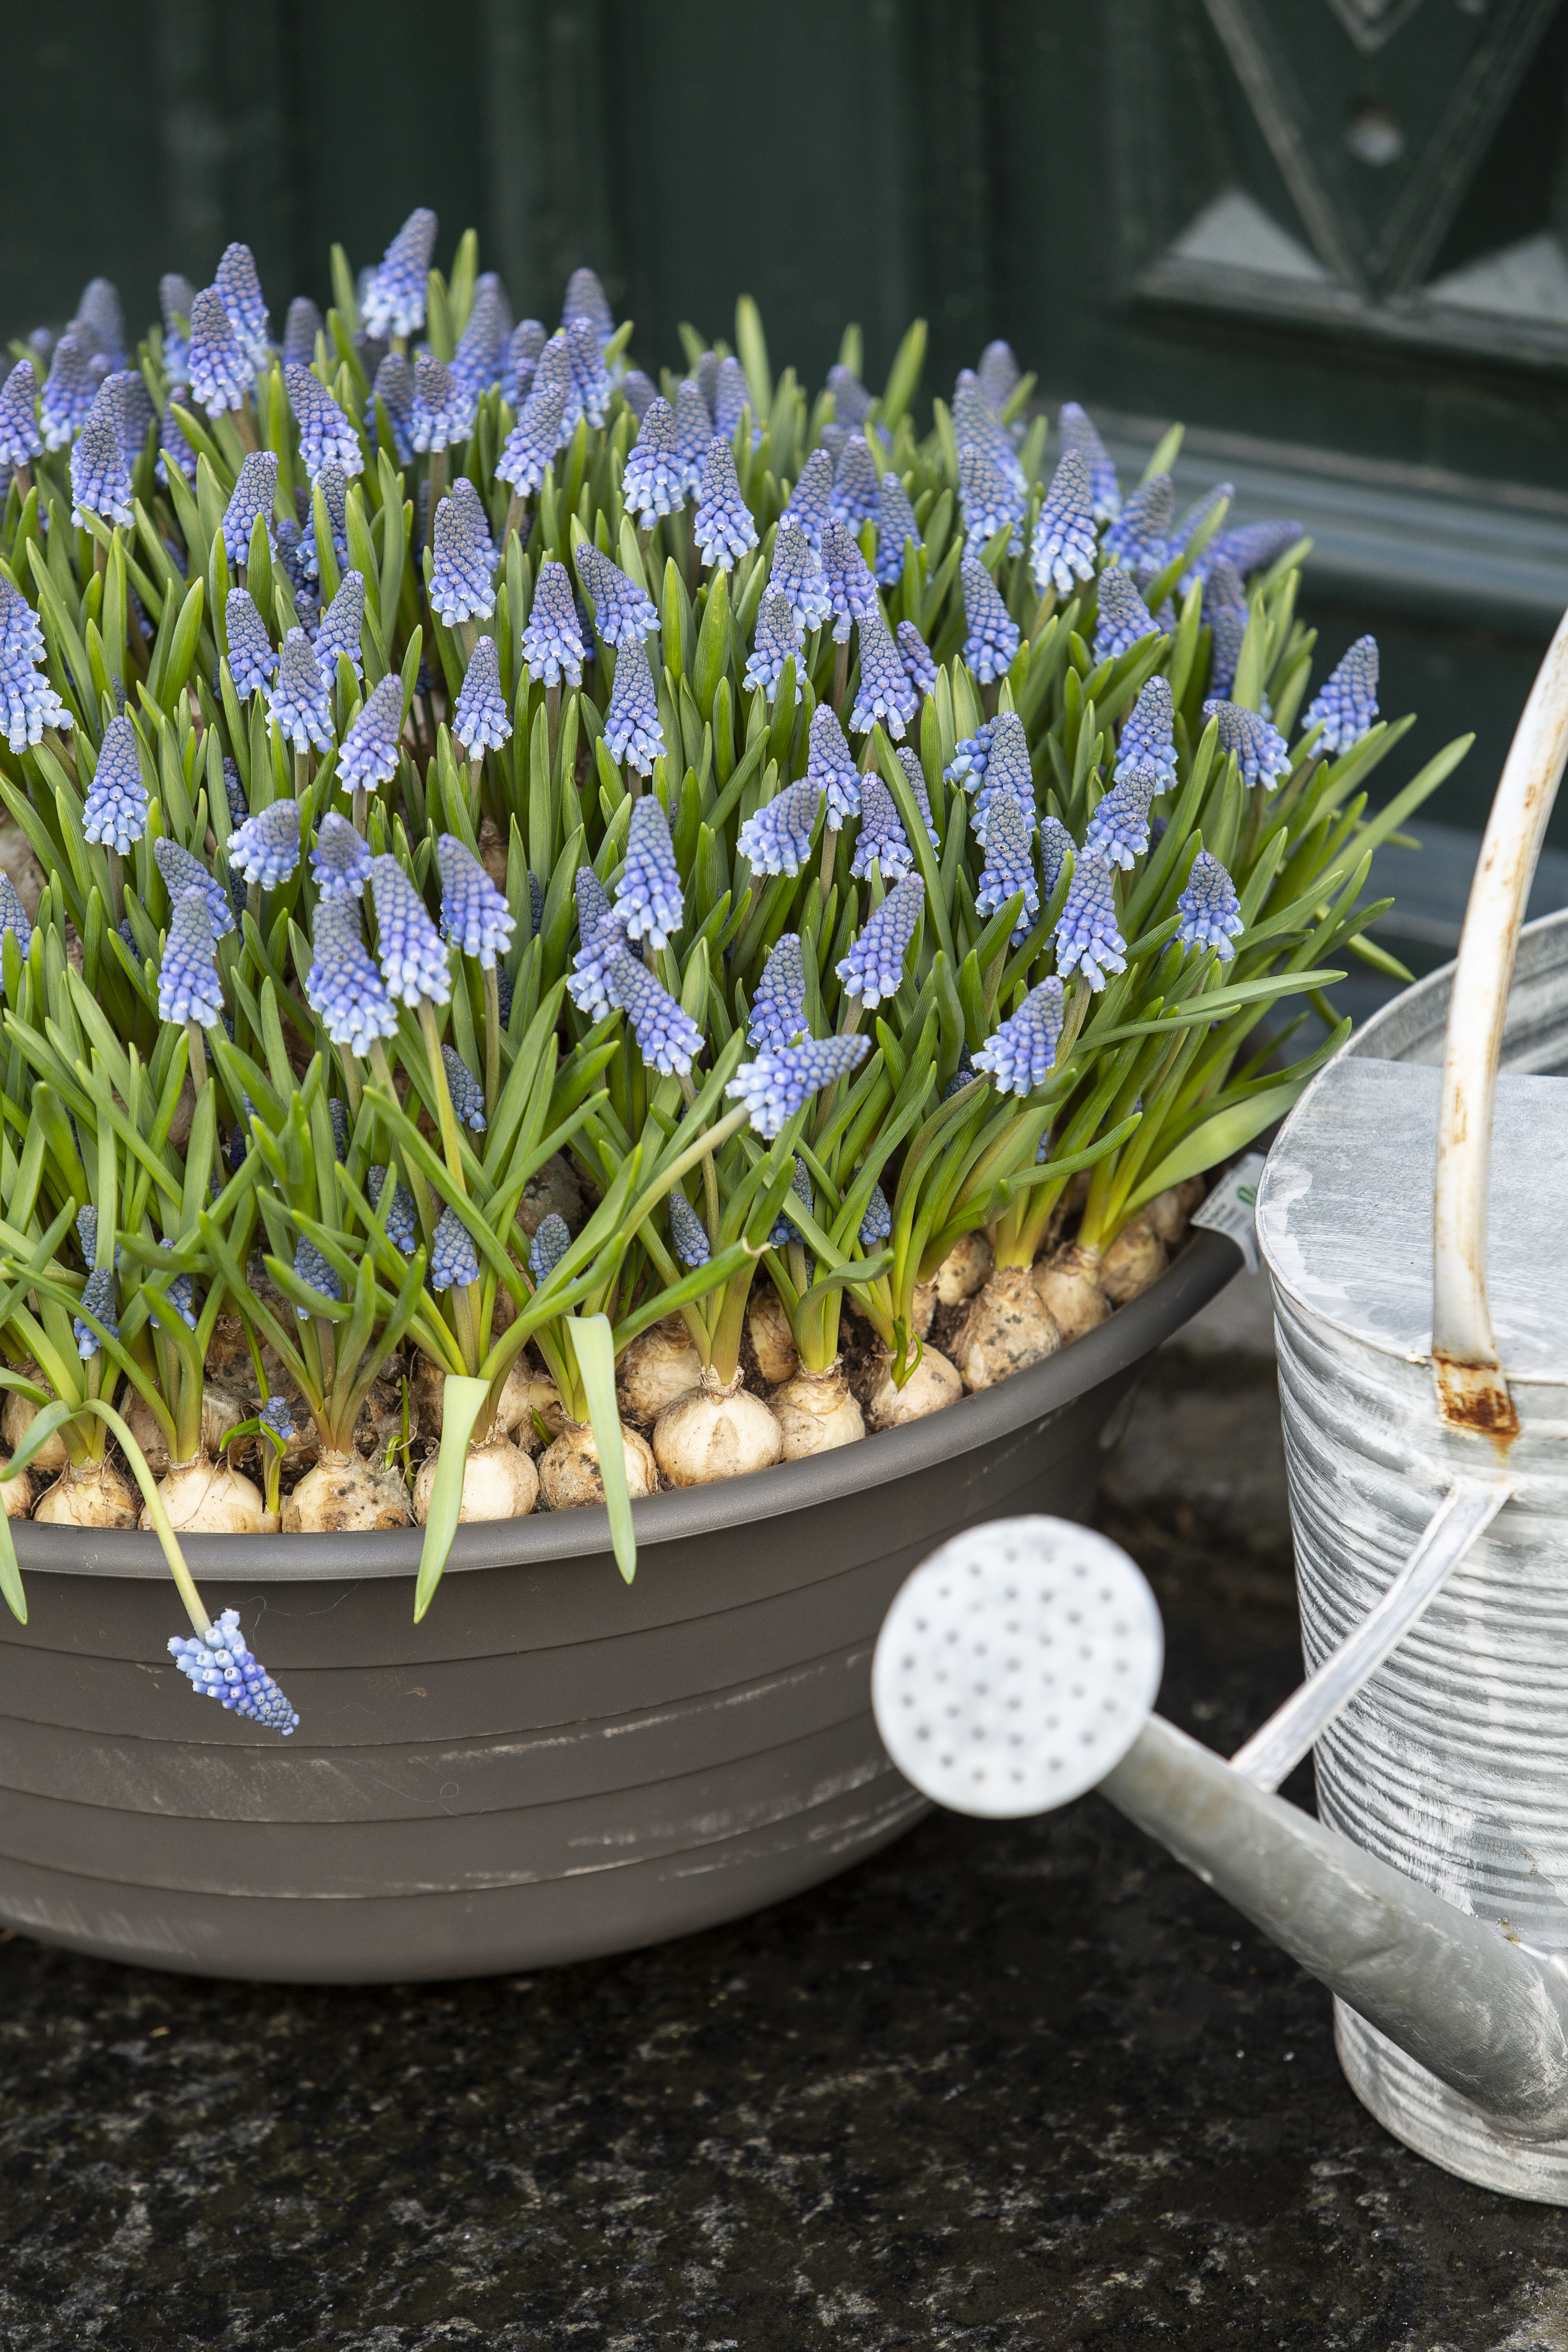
xmin=1432 ymin=614 xmax=1568 ymax=1442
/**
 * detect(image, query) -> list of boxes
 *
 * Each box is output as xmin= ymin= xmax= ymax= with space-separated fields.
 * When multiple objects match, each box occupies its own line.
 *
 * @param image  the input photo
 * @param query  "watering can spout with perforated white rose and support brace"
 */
xmin=872 ymin=1489 xmax=1568 ymax=2140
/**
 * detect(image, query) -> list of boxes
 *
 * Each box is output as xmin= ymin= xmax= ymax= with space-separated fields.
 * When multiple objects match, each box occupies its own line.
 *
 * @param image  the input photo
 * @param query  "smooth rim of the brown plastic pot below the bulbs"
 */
xmin=12 ymin=1228 xmax=1241 ymax=1583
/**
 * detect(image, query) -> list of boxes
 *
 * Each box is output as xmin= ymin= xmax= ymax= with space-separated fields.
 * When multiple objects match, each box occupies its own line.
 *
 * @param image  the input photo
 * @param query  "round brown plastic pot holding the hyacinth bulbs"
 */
xmin=0 ymin=1232 xmax=1239 ymax=1983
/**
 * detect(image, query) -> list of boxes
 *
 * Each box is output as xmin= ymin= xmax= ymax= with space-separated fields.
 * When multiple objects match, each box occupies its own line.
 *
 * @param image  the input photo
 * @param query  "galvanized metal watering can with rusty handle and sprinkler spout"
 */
xmin=872 ymin=621 xmax=1568 ymax=2204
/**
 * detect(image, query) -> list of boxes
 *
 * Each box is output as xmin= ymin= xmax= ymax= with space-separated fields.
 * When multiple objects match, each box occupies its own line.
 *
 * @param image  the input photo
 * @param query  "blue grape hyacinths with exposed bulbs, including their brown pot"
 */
xmin=0 ymin=212 xmax=1465 ymax=1976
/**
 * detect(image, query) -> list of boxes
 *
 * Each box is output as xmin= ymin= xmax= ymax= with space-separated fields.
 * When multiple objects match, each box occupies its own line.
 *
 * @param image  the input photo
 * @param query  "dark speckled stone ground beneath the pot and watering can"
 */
xmin=0 ymin=1326 xmax=1568 ymax=2352
